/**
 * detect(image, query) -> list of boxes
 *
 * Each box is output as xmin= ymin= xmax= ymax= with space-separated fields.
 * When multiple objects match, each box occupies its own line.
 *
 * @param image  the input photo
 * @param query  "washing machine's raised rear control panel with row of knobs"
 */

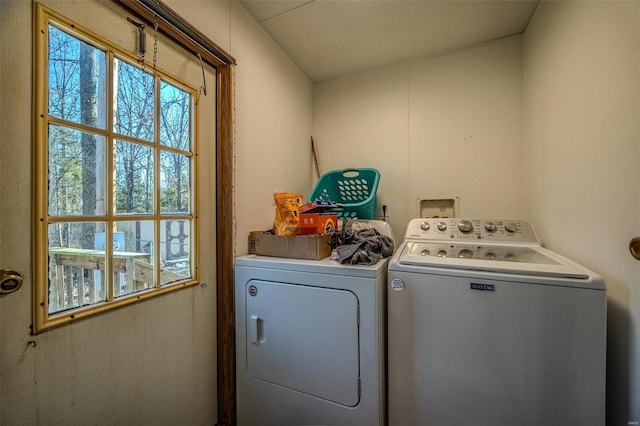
xmin=405 ymin=218 xmax=540 ymax=244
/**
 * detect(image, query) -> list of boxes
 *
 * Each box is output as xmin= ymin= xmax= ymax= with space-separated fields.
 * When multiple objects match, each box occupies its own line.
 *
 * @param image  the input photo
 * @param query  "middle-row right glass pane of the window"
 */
xmin=160 ymin=151 xmax=191 ymax=213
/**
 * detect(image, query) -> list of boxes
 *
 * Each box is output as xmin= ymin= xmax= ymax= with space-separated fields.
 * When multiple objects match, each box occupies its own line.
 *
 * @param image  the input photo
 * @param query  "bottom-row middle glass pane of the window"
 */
xmin=113 ymin=220 xmax=155 ymax=297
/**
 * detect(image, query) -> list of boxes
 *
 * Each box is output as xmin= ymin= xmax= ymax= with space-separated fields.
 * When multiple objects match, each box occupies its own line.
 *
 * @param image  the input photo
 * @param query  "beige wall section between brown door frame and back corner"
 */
xmin=167 ymin=0 xmax=313 ymax=255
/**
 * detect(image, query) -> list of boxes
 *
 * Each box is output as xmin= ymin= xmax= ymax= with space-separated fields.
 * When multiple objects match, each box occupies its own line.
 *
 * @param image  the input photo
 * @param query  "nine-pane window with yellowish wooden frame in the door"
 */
xmin=34 ymin=8 xmax=198 ymax=332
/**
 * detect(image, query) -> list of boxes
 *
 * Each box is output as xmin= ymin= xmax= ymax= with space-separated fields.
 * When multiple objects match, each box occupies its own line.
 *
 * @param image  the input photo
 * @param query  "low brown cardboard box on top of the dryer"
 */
xmin=249 ymin=231 xmax=331 ymax=260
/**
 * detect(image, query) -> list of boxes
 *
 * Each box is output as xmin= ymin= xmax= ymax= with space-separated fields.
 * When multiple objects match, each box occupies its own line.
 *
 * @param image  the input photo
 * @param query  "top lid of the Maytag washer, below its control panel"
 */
xmin=398 ymin=241 xmax=591 ymax=280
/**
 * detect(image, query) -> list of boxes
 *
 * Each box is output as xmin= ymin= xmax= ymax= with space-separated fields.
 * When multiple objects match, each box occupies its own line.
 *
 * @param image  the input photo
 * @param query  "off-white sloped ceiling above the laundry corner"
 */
xmin=240 ymin=0 xmax=538 ymax=82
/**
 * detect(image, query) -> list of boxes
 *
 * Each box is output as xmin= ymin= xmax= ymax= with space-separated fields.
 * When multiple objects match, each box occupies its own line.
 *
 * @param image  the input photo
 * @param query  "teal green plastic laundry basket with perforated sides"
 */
xmin=309 ymin=168 xmax=380 ymax=219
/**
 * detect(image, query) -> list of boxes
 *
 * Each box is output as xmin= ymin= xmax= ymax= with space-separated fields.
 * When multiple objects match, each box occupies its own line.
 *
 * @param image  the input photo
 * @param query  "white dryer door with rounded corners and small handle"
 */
xmin=245 ymin=280 xmax=360 ymax=407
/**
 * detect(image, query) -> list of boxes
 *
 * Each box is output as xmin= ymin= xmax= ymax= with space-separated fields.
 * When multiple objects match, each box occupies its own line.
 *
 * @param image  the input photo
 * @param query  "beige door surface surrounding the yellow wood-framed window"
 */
xmin=0 ymin=1 xmax=217 ymax=425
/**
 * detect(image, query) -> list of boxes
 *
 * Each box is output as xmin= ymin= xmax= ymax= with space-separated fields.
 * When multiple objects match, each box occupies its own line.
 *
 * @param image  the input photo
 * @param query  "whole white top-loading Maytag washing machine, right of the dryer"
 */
xmin=387 ymin=219 xmax=606 ymax=426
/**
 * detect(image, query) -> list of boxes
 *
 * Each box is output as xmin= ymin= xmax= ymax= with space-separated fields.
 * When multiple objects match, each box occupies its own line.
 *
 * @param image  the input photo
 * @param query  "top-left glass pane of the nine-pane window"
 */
xmin=48 ymin=25 xmax=106 ymax=129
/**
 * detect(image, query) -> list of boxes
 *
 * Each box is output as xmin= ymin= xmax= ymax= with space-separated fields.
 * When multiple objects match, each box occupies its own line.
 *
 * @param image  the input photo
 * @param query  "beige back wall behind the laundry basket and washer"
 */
xmin=313 ymin=36 xmax=525 ymax=241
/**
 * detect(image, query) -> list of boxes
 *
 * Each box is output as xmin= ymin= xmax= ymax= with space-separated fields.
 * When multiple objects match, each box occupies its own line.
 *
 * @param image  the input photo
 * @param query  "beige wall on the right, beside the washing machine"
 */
xmin=524 ymin=1 xmax=640 ymax=425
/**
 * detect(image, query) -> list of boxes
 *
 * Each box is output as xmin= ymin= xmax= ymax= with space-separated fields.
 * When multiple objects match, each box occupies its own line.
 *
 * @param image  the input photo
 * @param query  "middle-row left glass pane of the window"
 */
xmin=48 ymin=125 xmax=106 ymax=216
